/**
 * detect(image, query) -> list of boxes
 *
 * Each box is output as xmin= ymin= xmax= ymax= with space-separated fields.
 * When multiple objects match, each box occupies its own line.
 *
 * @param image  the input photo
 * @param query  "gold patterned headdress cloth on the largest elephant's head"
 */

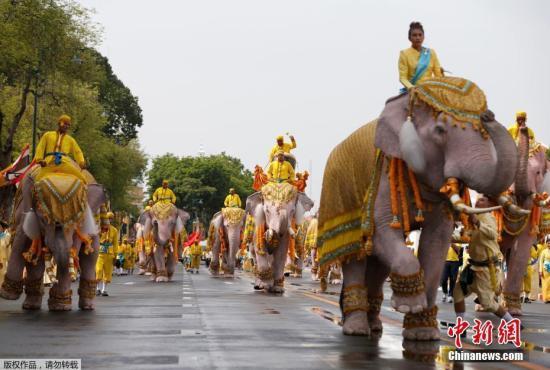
xmin=409 ymin=77 xmax=489 ymax=139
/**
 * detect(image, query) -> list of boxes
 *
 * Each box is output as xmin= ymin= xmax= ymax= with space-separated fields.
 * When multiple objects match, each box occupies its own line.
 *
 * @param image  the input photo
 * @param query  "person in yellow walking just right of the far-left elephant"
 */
xmin=96 ymin=213 xmax=118 ymax=296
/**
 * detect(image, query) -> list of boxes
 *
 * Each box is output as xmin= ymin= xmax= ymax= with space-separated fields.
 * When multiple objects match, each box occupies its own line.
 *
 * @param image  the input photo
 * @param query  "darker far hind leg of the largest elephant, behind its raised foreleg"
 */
xmin=365 ymin=256 xmax=390 ymax=332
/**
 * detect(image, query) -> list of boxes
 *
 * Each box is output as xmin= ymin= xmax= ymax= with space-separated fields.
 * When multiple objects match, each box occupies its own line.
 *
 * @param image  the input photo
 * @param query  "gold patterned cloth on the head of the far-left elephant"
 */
xmin=34 ymin=173 xmax=88 ymax=227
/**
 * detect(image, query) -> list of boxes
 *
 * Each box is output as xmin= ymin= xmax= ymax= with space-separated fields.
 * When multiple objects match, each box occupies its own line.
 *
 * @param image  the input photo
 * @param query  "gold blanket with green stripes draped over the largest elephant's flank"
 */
xmin=317 ymin=120 xmax=377 ymax=265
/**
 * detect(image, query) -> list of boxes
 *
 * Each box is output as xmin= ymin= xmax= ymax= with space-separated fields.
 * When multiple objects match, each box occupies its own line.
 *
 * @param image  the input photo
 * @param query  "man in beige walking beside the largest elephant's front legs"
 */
xmin=453 ymin=197 xmax=513 ymax=321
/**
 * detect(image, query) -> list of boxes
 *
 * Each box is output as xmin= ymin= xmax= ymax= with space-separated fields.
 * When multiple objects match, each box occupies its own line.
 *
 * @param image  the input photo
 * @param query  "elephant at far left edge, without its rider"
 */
xmin=0 ymin=168 xmax=106 ymax=311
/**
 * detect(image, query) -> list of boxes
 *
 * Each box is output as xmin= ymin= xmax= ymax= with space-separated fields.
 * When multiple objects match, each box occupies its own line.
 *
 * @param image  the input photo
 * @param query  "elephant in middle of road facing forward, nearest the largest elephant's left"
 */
xmin=246 ymin=182 xmax=313 ymax=294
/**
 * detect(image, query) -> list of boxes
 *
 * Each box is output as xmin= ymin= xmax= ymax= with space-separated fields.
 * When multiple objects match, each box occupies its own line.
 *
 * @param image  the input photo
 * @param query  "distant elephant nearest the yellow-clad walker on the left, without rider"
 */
xmin=139 ymin=202 xmax=190 ymax=283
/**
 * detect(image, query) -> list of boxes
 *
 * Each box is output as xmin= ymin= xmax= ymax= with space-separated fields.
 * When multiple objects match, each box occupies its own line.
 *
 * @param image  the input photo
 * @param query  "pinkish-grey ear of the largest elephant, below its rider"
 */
xmin=374 ymin=94 xmax=409 ymax=158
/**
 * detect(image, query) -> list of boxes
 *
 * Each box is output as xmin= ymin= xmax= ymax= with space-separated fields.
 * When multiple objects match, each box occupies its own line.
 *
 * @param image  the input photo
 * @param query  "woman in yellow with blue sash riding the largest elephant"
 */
xmin=398 ymin=22 xmax=443 ymax=92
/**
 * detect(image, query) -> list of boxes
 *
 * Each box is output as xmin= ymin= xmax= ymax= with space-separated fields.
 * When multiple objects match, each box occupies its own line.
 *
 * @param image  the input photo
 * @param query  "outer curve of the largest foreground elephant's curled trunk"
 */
xmin=486 ymin=115 xmax=518 ymax=197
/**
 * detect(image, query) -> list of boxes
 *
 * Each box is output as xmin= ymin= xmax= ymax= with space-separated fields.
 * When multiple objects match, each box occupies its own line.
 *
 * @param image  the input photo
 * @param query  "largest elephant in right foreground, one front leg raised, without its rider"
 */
xmin=318 ymin=77 xmax=518 ymax=340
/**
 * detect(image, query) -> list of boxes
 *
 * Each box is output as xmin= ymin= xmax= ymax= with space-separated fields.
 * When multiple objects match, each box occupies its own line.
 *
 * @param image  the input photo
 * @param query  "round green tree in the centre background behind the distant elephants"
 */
xmin=147 ymin=153 xmax=254 ymax=223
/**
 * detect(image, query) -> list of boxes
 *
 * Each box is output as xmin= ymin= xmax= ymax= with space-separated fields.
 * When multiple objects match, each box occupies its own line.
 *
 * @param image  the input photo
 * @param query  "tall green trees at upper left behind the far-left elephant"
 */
xmin=0 ymin=0 xmax=147 ymax=217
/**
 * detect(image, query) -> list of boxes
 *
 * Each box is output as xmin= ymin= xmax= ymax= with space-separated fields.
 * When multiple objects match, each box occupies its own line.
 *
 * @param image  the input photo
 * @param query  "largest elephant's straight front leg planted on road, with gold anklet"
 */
xmin=403 ymin=211 xmax=454 ymax=341
